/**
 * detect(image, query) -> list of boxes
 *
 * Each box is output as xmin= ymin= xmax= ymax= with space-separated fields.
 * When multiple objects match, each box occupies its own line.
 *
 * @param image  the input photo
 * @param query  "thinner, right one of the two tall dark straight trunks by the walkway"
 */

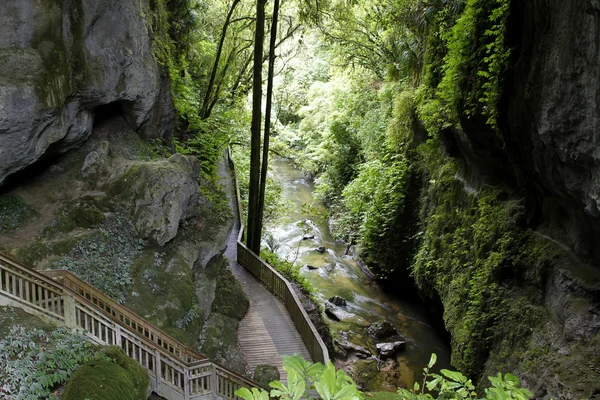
xmin=256 ymin=0 xmax=279 ymax=248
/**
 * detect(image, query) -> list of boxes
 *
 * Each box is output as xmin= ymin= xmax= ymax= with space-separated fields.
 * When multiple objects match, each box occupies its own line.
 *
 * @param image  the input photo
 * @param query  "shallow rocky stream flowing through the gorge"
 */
xmin=267 ymin=159 xmax=450 ymax=390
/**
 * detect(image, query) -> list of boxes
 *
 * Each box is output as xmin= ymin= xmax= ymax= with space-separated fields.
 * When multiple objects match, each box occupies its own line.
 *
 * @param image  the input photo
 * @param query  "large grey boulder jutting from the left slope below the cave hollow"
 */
xmin=107 ymin=154 xmax=200 ymax=246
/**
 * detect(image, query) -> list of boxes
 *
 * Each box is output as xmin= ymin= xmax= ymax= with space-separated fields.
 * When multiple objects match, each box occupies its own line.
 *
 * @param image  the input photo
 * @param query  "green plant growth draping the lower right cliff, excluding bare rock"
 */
xmin=413 ymin=142 xmax=556 ymax=375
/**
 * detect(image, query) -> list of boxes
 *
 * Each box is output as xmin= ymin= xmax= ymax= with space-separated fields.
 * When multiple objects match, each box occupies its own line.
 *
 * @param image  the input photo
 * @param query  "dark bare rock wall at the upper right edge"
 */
xmin=505 ymin=0 xmax=600 ymax=261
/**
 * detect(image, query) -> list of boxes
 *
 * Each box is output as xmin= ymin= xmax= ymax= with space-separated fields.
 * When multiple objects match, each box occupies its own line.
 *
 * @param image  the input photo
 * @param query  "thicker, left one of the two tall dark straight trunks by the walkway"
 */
xmin=246 ymin=0 xmax=267 ymax=254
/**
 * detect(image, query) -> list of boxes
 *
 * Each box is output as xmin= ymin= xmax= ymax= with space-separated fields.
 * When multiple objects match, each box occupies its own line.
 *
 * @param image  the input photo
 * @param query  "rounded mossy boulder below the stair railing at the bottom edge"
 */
xmin=62 ymin=346 xmax=150 ymax=400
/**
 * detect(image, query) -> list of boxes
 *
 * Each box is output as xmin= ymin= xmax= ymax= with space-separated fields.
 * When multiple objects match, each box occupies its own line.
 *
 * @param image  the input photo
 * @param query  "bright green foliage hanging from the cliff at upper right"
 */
xmin=419 ymin=0 xmax=510 ymax=134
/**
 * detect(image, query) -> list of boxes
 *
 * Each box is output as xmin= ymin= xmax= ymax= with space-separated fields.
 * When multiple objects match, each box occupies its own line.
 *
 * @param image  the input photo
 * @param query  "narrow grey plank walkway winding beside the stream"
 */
xmin=219 ymin=155 xmax=311 ymax=381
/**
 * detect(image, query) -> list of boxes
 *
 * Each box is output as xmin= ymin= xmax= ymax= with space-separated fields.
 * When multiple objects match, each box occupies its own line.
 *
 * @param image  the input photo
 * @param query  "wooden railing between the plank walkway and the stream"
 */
xmin=228 ymin=149 xmax=329 ymax=364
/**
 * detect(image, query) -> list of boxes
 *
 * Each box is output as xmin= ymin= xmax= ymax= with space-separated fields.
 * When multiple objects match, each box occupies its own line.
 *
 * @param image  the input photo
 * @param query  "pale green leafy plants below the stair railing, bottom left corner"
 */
xmin=0 ymin=325 xmax=99 ymax=400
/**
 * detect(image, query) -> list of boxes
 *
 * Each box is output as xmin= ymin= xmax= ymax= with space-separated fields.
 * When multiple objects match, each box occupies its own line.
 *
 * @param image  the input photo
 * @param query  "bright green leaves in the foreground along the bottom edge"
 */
xmin=236 ymin=354 xmax=533 ymax=400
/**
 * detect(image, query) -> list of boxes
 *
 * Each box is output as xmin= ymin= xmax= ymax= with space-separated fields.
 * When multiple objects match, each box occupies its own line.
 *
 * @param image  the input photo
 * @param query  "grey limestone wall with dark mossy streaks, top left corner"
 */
xmin=0 ymin=0 xmax=174 ymax=184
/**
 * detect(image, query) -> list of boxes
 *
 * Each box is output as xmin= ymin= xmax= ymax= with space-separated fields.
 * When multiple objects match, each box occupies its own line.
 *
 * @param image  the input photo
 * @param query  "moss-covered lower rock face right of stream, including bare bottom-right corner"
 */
xmin=412 ymin=143 xmax=600 ymax=398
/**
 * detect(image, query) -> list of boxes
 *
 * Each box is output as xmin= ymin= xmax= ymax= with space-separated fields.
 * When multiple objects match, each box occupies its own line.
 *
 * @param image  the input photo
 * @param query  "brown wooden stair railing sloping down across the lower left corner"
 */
xmin=0 ymin=254 xmax=259 ymax=400
